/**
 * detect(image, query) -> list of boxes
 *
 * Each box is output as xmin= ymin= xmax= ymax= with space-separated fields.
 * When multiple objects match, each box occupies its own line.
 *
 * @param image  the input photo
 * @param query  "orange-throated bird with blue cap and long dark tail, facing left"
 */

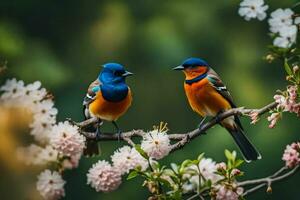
xmin=173 ymin=58 xmax=261 ymax=162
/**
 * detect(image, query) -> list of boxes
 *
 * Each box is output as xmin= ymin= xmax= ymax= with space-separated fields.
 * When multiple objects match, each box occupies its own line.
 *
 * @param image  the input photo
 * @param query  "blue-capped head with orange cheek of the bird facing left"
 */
xmin=173 ymin=58 xmax=209 ymax=79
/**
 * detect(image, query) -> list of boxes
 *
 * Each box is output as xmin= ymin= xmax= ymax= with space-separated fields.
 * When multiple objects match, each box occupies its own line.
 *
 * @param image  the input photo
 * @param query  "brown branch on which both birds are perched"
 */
xmin=67 ymin=102 xmax=277 ymax=151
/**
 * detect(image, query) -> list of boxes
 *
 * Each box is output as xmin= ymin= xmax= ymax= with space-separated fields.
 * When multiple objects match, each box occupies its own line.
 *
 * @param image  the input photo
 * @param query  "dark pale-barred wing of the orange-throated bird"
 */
xmin=207 ymin=69 xmax=243 ymax=130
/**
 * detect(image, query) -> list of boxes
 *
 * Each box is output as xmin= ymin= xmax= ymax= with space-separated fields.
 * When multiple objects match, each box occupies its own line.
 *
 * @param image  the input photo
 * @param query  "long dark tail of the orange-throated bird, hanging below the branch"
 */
xmin=226 ymin=119 xmax=261 ymax=162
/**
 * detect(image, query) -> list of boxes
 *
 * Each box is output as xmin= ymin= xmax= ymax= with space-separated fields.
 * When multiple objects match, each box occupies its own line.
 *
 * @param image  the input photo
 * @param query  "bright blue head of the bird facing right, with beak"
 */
xmin=99 ymin=63 xmax=133 ymax=84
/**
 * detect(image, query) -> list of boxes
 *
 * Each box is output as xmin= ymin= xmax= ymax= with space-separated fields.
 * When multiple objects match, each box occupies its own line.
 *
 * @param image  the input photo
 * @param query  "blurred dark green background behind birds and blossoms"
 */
xmin=0 ymin=0 xmax=300 ymax=200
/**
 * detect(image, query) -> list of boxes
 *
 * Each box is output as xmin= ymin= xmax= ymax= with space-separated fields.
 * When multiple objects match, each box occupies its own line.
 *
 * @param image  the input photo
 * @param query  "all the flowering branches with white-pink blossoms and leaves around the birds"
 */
xmin=0 ymin=0 xmax=300 ymax=200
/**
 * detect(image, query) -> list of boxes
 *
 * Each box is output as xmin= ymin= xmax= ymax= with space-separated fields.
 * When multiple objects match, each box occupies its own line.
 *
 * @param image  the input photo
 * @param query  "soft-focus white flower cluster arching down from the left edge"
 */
xmin=0 ymin=78 xmax=57 ymax=144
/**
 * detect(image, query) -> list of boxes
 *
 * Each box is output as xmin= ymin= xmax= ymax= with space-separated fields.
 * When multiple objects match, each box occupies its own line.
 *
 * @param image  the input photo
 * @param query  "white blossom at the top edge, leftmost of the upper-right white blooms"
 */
xmin=239 ymin=0 xmax=269 ymax=21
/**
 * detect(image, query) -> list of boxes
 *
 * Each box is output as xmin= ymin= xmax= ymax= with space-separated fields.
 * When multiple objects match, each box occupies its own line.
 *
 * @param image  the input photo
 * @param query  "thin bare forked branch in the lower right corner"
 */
xmin=238 ymin=165 xmax=300 ymax=196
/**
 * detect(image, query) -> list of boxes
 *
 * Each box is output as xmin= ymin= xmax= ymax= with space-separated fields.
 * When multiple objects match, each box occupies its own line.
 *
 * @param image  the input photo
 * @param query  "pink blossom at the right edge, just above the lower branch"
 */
xmin=282 ymin=142 xmax=300 ymax=168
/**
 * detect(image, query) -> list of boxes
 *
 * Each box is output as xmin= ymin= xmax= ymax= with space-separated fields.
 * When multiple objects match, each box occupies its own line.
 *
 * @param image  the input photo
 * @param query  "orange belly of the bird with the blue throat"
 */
xmin=89 ymin=89 xmax=132 ymax=121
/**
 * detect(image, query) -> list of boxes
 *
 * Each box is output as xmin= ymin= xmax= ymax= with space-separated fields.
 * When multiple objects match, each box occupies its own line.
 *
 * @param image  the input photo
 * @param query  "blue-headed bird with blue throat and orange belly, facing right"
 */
xmin=83 ymin=62 xmax=133 ymax=156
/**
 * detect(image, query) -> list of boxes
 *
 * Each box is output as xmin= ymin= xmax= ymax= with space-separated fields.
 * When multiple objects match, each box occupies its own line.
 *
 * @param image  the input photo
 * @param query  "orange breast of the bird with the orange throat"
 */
xmin=184 ymin=78 xmax=231 ymax=117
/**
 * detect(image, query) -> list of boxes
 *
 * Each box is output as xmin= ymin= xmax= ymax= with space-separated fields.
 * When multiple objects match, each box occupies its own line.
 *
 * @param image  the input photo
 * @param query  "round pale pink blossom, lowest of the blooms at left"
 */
xmin=36 ymin=169 xmax=66 ymax=200
